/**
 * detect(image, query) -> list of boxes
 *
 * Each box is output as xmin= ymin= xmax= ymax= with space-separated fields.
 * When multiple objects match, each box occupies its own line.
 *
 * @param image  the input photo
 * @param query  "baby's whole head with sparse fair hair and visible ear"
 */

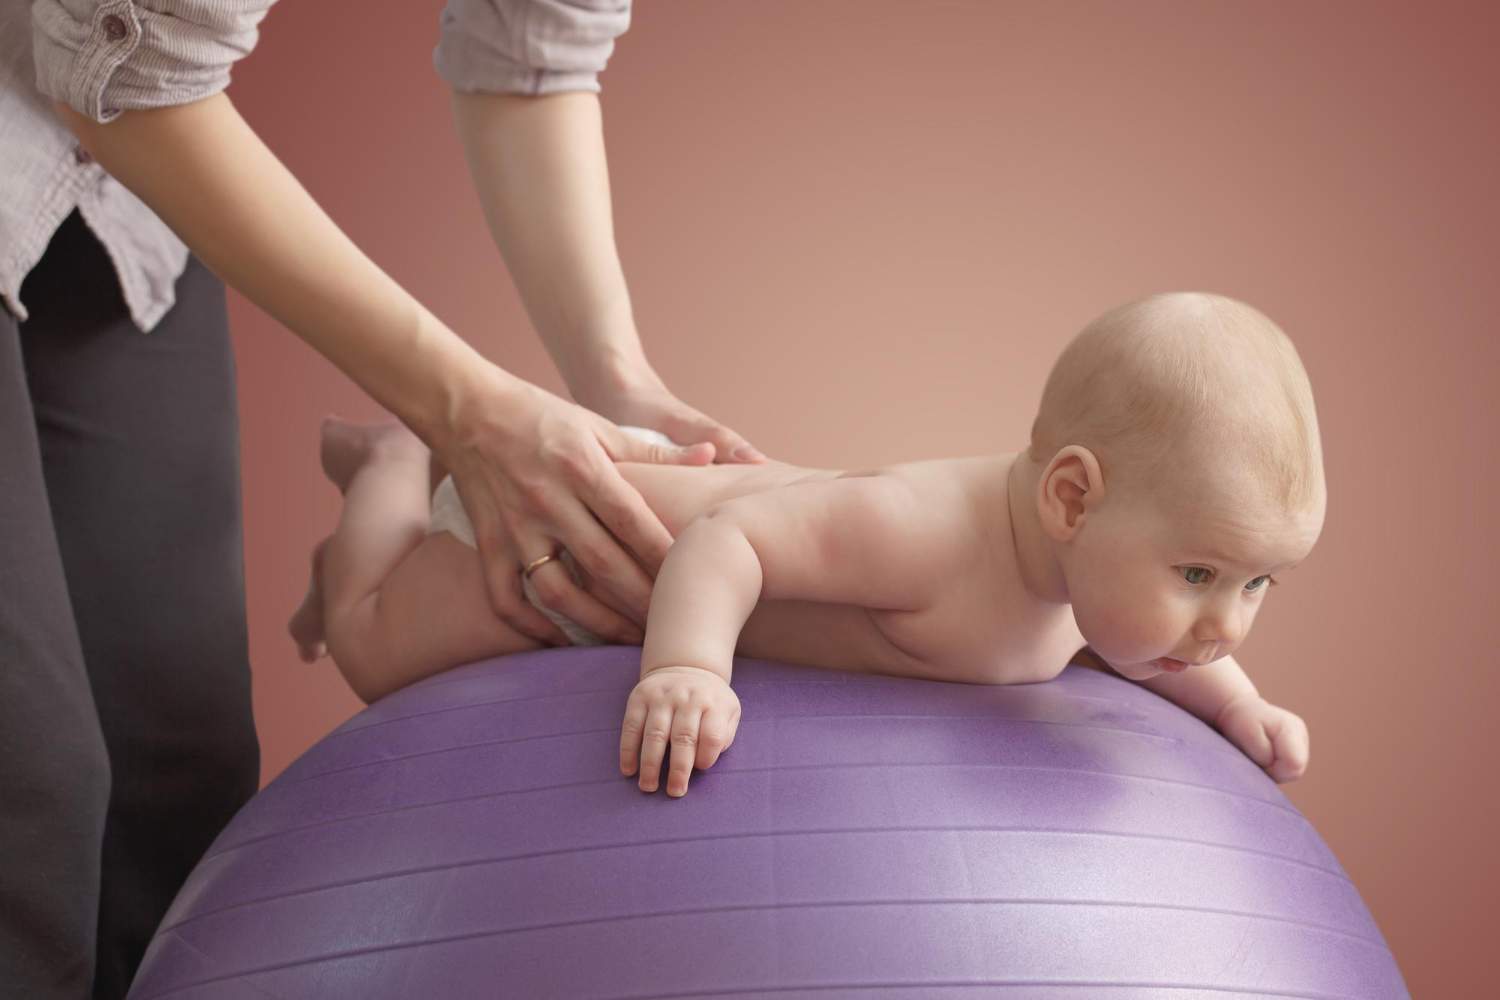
xmin=1026 ymin=292 xmax=1326 ymax=681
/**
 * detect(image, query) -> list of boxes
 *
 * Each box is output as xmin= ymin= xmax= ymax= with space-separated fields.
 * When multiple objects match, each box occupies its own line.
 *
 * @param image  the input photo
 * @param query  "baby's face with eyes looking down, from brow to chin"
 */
xmin=1065 ymin=476 xmax=1323 ymax=681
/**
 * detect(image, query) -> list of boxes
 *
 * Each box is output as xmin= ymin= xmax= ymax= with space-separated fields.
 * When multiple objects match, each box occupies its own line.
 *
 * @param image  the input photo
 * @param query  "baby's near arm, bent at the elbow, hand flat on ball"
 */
xmin=620 ymin=475 xmax=963 ymax=796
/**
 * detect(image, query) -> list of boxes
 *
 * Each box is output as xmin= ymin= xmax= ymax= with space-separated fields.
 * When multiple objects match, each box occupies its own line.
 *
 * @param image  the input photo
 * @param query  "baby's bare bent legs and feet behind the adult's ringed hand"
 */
xmin=293 ymin=418 xmax=540 ymax=702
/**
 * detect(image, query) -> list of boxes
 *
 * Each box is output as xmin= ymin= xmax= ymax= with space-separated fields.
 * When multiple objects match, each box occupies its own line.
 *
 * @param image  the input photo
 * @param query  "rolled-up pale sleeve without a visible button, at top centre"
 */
xmin=432 ymin=0 xmax=630 ymax=94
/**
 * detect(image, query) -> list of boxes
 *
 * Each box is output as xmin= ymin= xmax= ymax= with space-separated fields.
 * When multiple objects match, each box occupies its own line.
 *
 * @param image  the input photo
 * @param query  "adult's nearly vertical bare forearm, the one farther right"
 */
xmin=453 ymin=93 xmax=645 ymax=403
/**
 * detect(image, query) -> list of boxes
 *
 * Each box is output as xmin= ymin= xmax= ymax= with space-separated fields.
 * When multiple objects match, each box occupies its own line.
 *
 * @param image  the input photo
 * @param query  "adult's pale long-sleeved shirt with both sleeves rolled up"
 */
xmin=0 ymin=0 xmax=630 ymax=331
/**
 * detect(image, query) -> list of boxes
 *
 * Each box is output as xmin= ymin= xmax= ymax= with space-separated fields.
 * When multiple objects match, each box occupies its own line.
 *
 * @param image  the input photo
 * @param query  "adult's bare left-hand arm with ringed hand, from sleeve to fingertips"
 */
xmin=59 ymin=94 xmax=707 ymax=643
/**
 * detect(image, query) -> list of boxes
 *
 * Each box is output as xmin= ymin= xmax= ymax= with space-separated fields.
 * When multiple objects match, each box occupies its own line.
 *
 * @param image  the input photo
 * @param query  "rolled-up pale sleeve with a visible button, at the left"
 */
xmin=32 ymin=0 xmax=275 ymax=121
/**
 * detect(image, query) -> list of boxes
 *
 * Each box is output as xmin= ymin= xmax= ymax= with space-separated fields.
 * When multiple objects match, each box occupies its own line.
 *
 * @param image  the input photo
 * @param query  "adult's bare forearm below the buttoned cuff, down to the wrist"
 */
xmin=57 ymin=94 xmax=507 ymax=448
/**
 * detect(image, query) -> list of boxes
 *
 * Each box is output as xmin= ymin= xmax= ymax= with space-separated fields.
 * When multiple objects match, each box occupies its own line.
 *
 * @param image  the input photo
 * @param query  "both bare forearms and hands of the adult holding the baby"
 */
xmin=57 ymin=93 xmax=759 ymax=656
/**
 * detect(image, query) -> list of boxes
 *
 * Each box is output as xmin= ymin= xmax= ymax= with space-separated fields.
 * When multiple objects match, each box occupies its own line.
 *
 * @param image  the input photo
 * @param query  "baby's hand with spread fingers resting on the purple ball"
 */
xmin=620 ymin=667 xmax=740 ymax=798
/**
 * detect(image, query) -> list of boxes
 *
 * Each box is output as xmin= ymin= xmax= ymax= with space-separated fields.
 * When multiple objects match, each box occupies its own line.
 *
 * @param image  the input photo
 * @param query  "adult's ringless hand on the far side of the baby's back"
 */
xmin=570 ymin=360 xmax=765 ymax=463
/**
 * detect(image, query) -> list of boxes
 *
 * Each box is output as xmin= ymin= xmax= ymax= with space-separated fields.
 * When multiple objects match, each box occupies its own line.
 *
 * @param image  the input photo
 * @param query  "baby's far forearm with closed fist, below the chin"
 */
xmin=1140 ymin=657 xmax=1308 ymax=781
